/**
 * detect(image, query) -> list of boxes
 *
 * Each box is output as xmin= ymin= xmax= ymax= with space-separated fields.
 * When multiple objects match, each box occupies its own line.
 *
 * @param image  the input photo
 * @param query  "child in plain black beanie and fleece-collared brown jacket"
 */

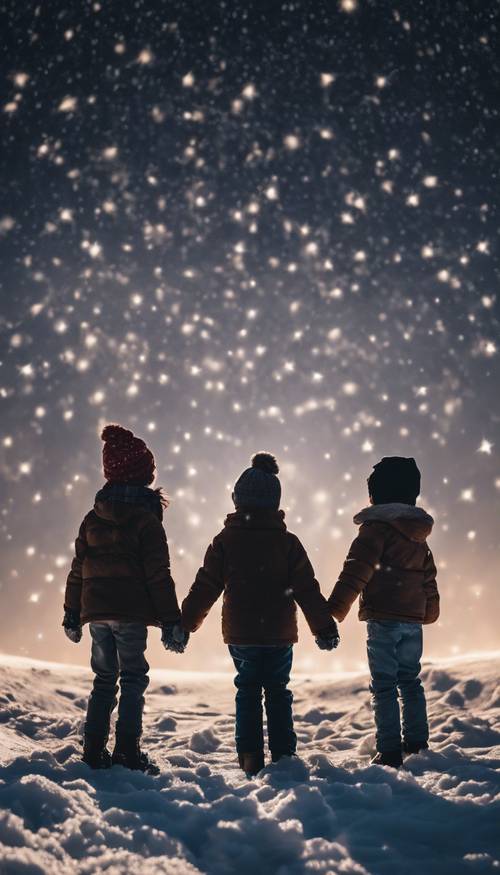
xmin=328 ymin=456 xmax=439 ymax=768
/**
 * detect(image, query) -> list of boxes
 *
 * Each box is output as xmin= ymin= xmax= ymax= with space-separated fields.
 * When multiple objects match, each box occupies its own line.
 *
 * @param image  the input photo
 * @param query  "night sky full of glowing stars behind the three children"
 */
xmin=0 ymin=0 xmax=500 ymax=671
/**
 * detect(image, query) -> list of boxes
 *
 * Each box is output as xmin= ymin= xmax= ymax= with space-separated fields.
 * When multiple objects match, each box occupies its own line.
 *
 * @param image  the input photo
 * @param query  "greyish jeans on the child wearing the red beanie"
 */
xmin=85 ymin=621 xmax=149 ymax=738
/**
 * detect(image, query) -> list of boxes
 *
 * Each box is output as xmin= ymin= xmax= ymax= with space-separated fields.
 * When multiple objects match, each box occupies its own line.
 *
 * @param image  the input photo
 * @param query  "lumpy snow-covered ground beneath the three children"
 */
xmin=0 ymin=654 xmax=500 ymax=875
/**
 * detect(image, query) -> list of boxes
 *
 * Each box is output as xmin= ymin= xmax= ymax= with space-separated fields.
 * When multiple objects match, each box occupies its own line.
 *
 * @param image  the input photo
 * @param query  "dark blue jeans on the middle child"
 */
xmin=229 ymin=644 xmax=297 ymax=757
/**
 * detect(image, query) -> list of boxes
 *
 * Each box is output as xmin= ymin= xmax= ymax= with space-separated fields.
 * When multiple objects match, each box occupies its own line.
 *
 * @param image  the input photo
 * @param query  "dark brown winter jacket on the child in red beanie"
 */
xmin=64 ymin=500 xmax=180 ymax=626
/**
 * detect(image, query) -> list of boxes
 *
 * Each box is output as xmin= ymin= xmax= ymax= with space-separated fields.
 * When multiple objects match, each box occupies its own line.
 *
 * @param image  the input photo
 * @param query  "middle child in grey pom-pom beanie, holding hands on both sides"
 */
xmin=182 ymin=453 xmax=339 ymax=775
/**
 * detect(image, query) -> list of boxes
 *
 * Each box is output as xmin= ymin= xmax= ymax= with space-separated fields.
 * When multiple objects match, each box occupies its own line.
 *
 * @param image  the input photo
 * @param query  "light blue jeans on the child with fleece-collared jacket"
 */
xmin=367 ymin=620 xmax=429 ymax=753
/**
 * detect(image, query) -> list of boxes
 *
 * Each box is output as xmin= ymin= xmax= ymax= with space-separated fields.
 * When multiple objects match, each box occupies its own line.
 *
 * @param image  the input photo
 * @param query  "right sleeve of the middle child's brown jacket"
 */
xmin=289 ymin=536 xmax=336 ymax=635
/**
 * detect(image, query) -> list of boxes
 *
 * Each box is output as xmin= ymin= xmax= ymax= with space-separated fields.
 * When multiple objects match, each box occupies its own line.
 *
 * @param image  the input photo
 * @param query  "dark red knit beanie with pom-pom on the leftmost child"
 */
xmin=101 ymin=425 xmax=156 ymax=486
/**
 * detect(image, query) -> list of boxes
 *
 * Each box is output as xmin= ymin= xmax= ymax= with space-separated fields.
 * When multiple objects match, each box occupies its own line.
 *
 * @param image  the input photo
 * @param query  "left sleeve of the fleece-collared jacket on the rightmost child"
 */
xmin=328 ymin=523 xmax=384 ymax=620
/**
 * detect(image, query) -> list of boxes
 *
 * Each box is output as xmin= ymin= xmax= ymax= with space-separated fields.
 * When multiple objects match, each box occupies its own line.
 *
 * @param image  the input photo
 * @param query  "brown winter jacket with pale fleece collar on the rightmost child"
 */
xmin=328 ymin=504 xmax=439 ymax=623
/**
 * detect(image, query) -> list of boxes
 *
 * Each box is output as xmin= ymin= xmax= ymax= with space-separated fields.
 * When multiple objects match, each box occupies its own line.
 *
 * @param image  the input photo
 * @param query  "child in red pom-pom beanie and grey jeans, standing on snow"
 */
xmin=63 ymin=425 xmax=183 ymax=774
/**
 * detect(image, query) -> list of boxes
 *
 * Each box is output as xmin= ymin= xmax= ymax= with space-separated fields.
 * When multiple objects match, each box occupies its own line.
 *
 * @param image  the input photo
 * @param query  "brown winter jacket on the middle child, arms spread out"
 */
xmin=182 ymin=510 xmax=333 ymax=645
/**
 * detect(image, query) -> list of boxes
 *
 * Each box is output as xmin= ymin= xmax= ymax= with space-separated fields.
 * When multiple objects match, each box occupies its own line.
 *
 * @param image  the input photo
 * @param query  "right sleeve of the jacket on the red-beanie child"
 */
xmin=139 ymin=514 xmax=181 ymax=623
